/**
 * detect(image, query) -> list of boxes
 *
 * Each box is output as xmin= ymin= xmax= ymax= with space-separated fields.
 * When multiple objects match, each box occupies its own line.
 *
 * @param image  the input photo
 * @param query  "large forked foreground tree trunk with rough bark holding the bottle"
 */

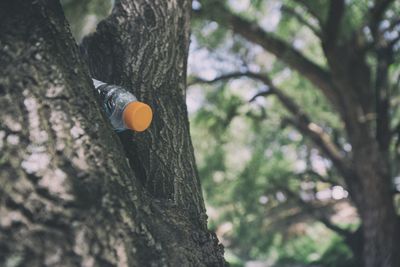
xmin=0 ymin=0 xmax=225 ymax=266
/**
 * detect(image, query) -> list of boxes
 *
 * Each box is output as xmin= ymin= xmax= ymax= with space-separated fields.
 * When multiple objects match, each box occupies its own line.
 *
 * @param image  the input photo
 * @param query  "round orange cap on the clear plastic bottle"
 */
xmin=122 ymin=101 xmax=153 ymax=132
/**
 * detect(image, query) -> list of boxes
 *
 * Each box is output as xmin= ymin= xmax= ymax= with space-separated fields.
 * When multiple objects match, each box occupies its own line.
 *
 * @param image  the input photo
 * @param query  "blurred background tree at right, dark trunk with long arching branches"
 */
xmin=196 ymin=0 xmax=400 ymax=267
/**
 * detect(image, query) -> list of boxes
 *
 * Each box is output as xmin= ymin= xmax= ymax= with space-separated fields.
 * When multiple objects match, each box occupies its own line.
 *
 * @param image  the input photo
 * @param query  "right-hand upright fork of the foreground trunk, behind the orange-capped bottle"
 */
xmin=83 ymin=0 xmax=204 ymax=222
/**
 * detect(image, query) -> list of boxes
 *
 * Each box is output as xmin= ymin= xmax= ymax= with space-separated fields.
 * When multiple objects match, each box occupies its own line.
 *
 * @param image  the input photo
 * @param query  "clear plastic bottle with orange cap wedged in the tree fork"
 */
xmin=92 ymin=79 xmax=153 ymax=132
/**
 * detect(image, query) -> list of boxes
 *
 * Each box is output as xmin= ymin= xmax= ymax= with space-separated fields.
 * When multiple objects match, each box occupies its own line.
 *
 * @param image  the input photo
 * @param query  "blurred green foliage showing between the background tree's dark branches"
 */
xmin=189 ymin=0 xmax=400 ymax=266
